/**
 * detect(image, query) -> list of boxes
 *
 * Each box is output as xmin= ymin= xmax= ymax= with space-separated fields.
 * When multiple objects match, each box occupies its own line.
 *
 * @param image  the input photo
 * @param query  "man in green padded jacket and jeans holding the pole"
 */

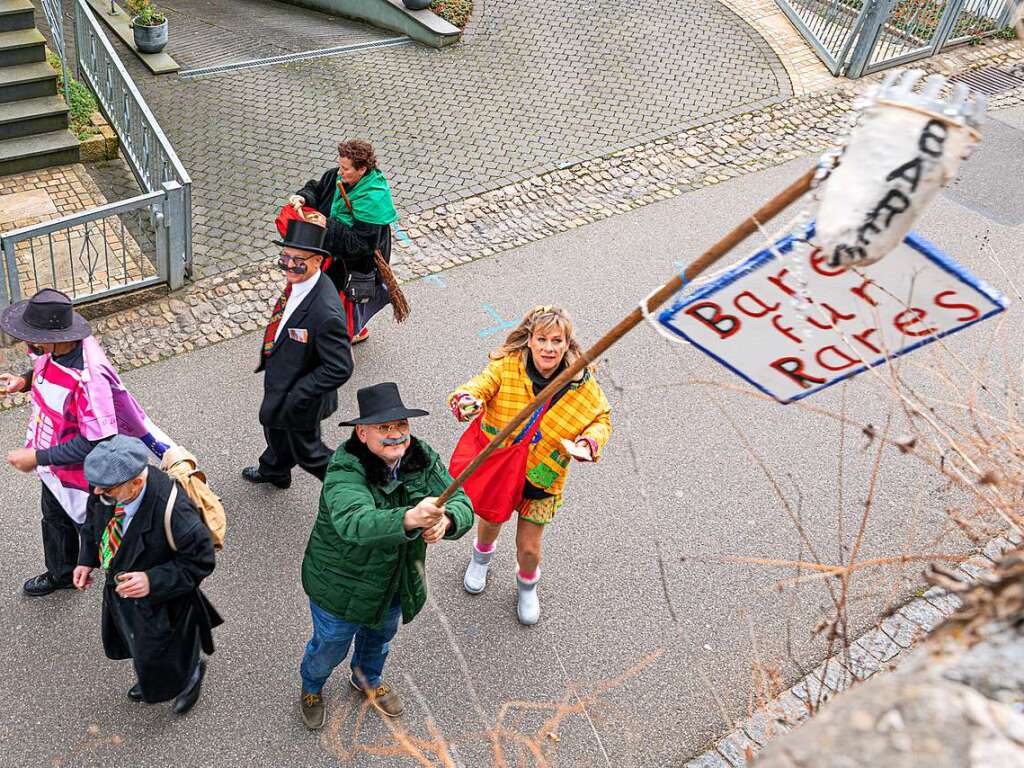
xmin=300 ymin=382 xmax=473 ymax=729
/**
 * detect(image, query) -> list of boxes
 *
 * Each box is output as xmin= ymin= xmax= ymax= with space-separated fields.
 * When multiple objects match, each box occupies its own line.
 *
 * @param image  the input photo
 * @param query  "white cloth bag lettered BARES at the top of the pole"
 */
xmin=817 ymin=70 xmax=985 ymax=267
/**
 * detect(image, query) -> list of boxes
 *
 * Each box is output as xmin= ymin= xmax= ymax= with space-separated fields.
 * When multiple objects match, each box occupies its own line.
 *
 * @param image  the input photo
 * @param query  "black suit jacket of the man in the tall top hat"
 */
xmin=256 ymin=275 xmax=352 ymax=431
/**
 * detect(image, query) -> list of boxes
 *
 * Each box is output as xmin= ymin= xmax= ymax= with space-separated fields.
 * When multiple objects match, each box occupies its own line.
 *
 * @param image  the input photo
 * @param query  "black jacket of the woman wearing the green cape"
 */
xmin=295 ymin=166 xmax=391 ymax=291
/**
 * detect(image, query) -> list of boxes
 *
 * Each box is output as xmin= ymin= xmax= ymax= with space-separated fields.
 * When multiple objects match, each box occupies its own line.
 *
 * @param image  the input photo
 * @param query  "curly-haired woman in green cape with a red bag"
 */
xmin=288 ymin=139 xmax=403 ymax=344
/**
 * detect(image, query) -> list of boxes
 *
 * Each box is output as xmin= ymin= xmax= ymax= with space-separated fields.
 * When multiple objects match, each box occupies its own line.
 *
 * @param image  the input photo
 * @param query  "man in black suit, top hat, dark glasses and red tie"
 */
xmin=242 ymin=219 xmax=352 ymax=488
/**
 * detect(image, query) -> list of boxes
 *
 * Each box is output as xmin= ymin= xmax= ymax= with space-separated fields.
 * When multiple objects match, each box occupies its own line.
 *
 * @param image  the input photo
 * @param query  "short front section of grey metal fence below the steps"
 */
xmin=0 ymin=181 xmax=184 ymax=306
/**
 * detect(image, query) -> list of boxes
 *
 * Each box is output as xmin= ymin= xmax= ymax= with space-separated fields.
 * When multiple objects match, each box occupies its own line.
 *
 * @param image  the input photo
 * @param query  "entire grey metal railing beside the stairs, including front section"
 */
xmin=0 ymin=0 xmax=191 ymax=307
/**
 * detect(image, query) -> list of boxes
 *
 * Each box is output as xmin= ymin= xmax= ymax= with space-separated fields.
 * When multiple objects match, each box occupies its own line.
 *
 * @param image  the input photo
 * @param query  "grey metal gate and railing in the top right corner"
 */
xmin=776 ymin=0 xmax=1012 ymax=78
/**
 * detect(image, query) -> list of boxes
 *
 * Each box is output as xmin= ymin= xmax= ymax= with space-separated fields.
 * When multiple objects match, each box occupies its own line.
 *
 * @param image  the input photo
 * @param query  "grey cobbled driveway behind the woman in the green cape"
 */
xmin=44 ymin=0 xmax=792 ymax=274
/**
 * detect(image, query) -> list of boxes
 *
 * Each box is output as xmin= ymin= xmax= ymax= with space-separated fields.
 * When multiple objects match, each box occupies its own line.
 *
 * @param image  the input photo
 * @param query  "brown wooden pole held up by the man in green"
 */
xmin=437 ymin=168 xmax=817 ymax=506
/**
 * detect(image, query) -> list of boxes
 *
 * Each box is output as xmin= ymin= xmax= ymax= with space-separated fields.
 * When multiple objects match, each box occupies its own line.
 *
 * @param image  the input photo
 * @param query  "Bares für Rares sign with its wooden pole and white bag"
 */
xmin=437 ymin=71 xmax=987 ymax=505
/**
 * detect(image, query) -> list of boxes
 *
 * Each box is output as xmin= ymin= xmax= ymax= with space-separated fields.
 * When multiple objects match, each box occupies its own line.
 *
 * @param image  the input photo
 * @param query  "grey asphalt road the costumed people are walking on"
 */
xmin=0 ymin=124 xmax=1022 ymax=768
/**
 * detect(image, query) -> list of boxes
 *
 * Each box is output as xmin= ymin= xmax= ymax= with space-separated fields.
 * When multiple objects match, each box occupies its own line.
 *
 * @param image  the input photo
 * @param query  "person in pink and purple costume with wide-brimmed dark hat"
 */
xmin=0 ymin=288 xmax=172 ymax=597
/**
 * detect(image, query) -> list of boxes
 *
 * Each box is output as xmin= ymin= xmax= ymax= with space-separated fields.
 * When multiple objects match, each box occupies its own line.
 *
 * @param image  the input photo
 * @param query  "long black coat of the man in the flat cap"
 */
xmin=79 ymin=467 xmax=223 ymax=703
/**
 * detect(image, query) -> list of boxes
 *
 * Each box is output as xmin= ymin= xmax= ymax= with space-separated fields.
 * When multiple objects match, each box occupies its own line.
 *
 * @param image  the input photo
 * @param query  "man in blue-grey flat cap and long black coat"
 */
xmin=74 ymin=435 xmax=222 ymax=715
